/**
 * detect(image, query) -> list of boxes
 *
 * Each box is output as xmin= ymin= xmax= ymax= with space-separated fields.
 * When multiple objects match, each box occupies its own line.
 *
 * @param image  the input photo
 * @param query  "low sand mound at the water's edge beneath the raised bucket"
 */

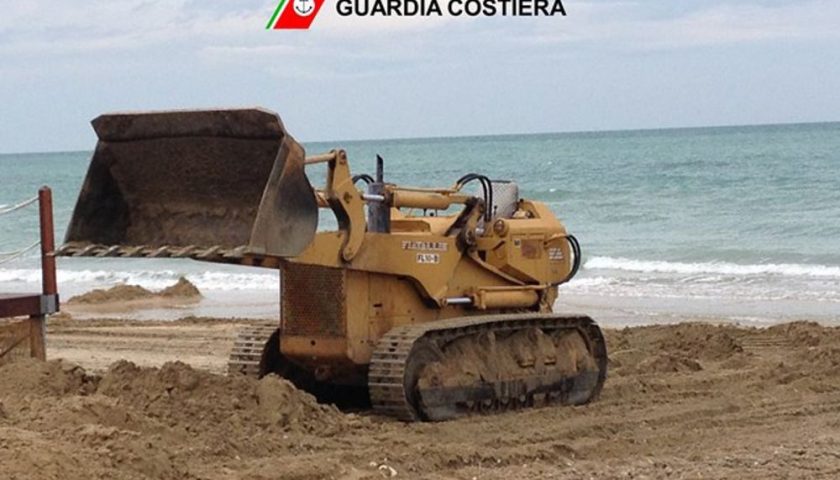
xmin=66 ymin=277 xmax=201 ymax=308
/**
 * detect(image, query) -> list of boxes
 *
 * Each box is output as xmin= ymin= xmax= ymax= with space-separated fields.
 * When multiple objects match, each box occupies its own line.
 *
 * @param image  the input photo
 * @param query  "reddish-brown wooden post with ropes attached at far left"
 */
xmin=29 ymin=187 xmax=58 ymax=360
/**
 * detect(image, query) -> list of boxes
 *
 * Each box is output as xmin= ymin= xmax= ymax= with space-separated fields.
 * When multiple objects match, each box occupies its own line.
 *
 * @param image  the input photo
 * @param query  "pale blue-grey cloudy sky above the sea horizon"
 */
xmin=0 ymin=0 xmax=840 ymax=153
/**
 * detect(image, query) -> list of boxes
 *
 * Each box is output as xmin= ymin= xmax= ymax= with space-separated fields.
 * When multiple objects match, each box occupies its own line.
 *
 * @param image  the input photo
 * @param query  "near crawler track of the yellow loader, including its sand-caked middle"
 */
xmin=368 ymin=314 xmax=607 ymax=421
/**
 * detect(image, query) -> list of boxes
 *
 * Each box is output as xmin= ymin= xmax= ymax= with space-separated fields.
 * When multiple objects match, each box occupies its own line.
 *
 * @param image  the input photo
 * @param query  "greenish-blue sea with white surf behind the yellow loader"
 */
xmin=0 ymin=123 xmax=840 ymax=326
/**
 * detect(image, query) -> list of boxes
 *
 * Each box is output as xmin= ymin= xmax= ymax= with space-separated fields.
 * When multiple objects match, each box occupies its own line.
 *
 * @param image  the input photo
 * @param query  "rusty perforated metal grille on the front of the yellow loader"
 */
xmin=283 ymin=264 xmax=347 ymax=337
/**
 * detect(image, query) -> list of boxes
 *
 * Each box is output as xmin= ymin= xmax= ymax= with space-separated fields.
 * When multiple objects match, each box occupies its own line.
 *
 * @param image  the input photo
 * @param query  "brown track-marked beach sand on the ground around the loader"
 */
xmin=0 ymin=316 xmax=840 ymax=479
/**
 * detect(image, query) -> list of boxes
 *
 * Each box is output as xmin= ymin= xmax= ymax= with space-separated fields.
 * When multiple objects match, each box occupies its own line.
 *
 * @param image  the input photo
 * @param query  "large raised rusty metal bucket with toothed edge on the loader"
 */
xmin=59 ymin=109 xmax=318 ymax=259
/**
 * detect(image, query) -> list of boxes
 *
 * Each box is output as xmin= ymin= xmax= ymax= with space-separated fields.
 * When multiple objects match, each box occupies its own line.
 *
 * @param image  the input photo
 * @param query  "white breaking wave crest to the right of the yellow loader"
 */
xmin=583 ymin=257 xmax=840 ymax=278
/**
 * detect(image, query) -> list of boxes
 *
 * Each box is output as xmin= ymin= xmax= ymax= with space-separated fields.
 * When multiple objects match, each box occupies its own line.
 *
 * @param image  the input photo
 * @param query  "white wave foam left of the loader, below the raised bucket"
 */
xmin=0 ymin=269 xmax=279 ymax=291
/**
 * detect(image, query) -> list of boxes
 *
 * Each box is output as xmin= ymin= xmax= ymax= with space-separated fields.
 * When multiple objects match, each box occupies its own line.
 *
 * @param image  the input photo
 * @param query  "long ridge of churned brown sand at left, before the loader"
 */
xmin=0 ymin=359 xmax=347 ymax=434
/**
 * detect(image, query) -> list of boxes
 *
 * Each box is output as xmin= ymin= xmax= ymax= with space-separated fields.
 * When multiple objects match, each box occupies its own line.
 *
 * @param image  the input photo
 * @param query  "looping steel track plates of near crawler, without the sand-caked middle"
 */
xmin=368 ymin=313 xmax=607 ymax=421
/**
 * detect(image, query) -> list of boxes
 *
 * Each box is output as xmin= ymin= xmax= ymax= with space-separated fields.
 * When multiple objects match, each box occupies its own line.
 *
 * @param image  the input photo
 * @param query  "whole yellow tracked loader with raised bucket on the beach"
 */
xmin=57 ymin=108 xmax=607 ymax=421
